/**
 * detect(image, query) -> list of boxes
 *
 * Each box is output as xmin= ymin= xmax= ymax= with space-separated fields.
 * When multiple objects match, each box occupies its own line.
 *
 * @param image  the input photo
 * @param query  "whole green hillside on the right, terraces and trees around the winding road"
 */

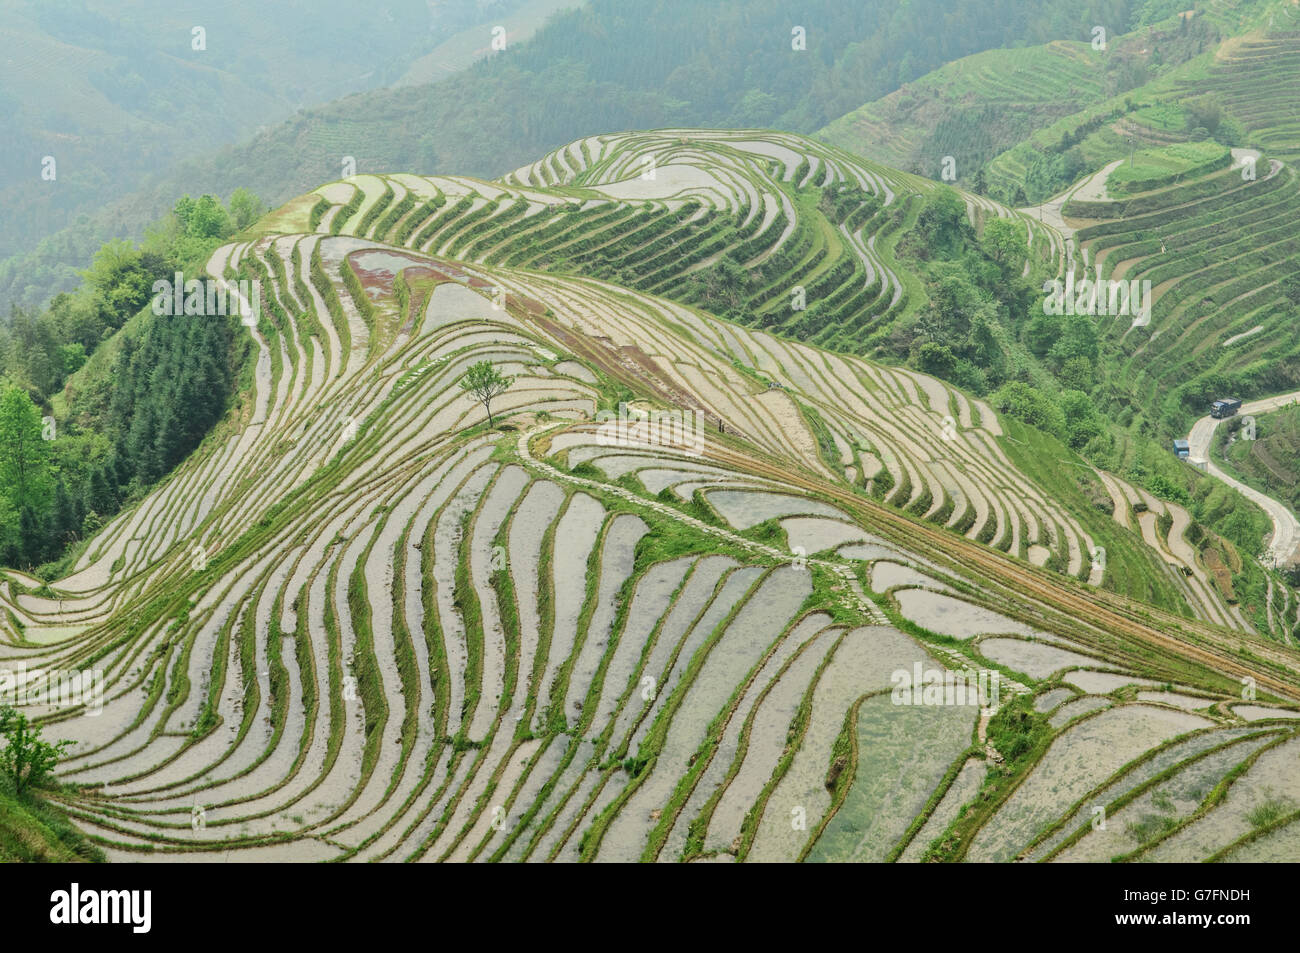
xmin=820 ymin=0 xmax=1300 ymax=637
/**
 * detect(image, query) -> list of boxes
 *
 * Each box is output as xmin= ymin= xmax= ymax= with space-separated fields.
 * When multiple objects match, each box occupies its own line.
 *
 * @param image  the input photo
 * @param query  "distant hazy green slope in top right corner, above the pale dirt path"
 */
xmin=816 ymin=0 xmax=1300 ymax=204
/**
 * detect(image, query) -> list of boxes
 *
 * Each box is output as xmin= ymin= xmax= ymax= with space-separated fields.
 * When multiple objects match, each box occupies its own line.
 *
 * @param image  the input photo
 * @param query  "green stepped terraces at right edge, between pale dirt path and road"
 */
xmin=1065 ymin=144 xmax=1300 ymax=419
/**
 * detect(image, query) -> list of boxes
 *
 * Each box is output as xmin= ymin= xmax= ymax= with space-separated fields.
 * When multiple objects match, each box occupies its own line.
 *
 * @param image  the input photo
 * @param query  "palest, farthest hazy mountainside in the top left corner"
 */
xmin=0 ymin=0 xmax=580 ymax=317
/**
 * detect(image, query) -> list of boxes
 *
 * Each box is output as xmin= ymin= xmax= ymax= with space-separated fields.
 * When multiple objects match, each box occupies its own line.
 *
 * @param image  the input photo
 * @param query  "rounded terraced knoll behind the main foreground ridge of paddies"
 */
xmin=271 ymin=129 xmax=1060 ymax=352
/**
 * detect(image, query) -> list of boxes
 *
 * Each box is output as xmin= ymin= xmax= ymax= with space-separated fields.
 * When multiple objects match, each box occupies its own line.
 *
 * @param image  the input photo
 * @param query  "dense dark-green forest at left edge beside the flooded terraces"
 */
xmin=0 ymin=191 xmax=264 ymax=567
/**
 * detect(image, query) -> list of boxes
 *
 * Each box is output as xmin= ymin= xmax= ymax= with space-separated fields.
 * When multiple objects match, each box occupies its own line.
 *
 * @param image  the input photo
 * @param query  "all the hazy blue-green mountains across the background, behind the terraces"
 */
xmin=0 ymin=0 xmax=1131 ymax=316
